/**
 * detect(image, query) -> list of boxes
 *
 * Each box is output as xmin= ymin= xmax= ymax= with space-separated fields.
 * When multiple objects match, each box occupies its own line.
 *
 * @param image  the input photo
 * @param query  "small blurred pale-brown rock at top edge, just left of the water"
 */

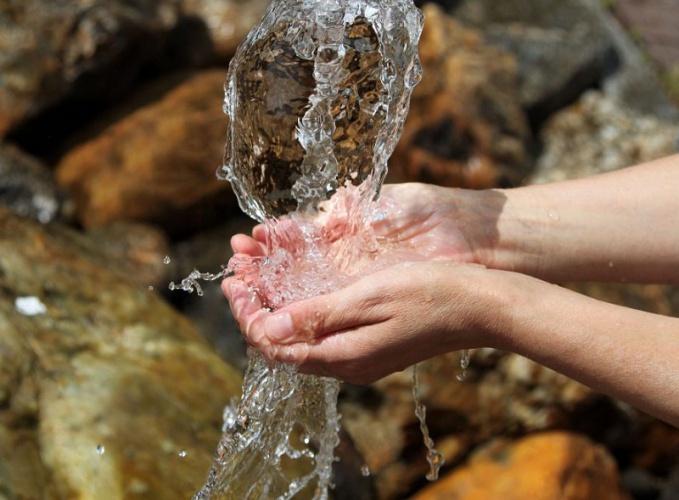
xmin=183 ymin=0 xmax=269 ymax=61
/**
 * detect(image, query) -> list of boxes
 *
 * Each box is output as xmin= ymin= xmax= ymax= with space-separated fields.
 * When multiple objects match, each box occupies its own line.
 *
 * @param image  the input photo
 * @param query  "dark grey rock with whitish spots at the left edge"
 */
xmin=0 ymin=144 xmax=72 ymax=224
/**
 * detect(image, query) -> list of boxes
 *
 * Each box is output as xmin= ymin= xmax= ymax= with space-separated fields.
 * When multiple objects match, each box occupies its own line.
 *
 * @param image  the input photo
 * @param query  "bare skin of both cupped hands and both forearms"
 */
xmin=223 ymin=156 xmax=679 ymax=426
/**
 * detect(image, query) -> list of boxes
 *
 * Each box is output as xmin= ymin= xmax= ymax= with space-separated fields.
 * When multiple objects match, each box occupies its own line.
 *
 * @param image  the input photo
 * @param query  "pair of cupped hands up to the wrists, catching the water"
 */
xmin=222 ymin=183 xmax=515 ymax=384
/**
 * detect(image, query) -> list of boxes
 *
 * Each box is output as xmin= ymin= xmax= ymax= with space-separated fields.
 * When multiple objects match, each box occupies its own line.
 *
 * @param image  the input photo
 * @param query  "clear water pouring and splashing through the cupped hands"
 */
xmin=191 ymin=0 xmax=442 ymax=500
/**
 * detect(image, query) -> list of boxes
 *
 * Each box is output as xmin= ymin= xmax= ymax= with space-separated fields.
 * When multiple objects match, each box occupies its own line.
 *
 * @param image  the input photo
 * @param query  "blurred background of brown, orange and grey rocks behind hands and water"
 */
xmin=0 ymin=0 xmax=679 ymax=500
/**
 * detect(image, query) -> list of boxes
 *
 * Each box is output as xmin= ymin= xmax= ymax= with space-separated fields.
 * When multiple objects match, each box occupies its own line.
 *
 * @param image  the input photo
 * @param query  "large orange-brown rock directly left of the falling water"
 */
xmin=57 ymin=70 xmax=235 ymax=236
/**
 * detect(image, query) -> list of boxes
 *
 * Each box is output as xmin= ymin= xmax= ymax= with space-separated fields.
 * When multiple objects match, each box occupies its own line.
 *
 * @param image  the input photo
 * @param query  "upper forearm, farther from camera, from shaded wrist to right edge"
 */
xmin=478 ymin=155 xmax=679 ymax=284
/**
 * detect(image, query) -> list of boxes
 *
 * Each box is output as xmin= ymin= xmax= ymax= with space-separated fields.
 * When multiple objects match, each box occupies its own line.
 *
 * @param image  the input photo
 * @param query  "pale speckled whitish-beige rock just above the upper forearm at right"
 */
xmin=527 ymin=91 xmax=679 ymax=184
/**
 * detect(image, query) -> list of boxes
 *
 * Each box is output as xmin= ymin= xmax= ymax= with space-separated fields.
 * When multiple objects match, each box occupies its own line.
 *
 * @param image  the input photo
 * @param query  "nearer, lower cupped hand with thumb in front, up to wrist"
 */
xmin=222 ymin=261 xmax=502 ymax=384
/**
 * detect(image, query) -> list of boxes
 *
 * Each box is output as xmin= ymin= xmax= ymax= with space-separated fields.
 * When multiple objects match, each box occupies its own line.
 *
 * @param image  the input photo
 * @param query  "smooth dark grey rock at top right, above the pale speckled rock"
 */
xmin=454 ymin=0 xmax=618 ymax=124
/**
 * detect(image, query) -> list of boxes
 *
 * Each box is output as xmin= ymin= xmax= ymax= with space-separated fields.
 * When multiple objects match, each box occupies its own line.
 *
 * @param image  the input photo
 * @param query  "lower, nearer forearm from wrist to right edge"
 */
xmin=488 ymin=273 xmax=679 ymax=426
